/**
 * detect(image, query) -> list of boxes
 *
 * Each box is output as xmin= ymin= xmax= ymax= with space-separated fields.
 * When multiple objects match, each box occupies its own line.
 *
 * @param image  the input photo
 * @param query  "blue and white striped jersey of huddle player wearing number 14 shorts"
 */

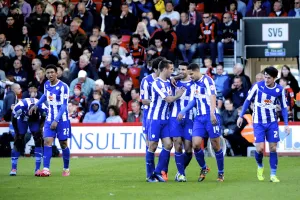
xmin=191 ymin=75 xmax=218 ymax=115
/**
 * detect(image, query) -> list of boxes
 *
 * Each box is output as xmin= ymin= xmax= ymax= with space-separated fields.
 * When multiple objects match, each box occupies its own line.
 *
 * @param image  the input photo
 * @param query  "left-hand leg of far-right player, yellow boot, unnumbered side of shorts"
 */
xmin=253 ymin=123 xmax=265 ymax=181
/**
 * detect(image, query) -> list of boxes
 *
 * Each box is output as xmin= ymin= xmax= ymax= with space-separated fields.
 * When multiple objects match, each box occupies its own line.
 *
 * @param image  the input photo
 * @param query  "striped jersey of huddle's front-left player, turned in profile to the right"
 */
xmin=147 ymin=78 xmax=173 ymax=120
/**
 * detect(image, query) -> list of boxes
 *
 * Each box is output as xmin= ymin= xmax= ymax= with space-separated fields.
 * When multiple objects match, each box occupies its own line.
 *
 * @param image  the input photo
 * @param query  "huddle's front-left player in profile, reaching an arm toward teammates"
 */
xmin=146 ymin=60 xmax=185 ymax=182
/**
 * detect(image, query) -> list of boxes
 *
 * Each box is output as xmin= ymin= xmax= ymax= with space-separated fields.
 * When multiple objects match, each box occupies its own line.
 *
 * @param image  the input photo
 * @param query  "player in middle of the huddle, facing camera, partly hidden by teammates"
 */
xmin=169 ymin=62 xmax=194 ymax=182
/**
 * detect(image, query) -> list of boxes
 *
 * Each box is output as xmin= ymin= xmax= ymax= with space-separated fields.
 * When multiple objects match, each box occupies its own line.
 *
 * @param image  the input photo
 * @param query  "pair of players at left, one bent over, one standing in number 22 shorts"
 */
xmin=10 ymin=65 xmax=71 ymax=177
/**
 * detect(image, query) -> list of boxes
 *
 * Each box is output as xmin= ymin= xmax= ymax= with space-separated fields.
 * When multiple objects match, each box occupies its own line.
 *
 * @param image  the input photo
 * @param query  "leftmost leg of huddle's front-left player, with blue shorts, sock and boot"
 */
xmin=146 ymin=120 xmax=160 ymax=182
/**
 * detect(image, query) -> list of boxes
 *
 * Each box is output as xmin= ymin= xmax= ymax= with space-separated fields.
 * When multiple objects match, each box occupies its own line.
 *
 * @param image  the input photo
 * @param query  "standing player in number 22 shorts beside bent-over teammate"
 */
xmin=29 ymin=65 xmax=71 ymax=176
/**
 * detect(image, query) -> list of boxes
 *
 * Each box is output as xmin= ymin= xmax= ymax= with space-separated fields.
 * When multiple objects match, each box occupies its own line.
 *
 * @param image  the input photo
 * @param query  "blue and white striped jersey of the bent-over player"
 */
xmin=12 ymin=98 xmax=48 ymax=121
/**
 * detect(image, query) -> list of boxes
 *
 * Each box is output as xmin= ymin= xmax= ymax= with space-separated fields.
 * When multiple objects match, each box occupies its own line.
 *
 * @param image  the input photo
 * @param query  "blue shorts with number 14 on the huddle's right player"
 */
xmin=192 ymin=114 xmax=221 ymax=138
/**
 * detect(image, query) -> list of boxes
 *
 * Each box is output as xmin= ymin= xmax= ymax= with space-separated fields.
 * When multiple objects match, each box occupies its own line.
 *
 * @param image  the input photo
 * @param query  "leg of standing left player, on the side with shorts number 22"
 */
xmin=57 ymin=121 xmax=71 ymax=176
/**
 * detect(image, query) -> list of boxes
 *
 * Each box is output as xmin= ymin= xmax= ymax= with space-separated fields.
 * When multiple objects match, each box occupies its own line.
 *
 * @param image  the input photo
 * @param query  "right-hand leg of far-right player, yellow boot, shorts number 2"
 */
xmin=266 ymin=122 xmax=280 ymax=183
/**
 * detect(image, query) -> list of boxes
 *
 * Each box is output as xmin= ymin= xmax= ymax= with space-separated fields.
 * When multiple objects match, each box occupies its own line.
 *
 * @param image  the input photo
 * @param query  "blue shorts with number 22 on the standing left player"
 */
xmin=44 ymin=121 xmax=71 ymax=141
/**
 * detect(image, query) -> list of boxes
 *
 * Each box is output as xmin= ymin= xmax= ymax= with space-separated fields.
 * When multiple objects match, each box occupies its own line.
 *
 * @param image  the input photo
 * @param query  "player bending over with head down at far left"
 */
xmin=9 ymin=98 xmax=48 ymax=176
